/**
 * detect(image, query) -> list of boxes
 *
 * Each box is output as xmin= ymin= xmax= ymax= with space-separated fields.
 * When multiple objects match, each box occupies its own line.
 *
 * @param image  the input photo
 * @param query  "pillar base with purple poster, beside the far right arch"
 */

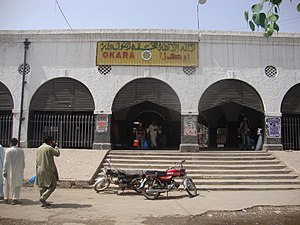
xmin=263 ymin=115 xmax=283 ymax=151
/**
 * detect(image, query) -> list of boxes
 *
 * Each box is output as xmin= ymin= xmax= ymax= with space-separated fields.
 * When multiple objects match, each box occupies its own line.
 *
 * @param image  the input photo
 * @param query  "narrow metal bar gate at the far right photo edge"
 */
xmin=282 ymin=116 xmax=300 ymax=149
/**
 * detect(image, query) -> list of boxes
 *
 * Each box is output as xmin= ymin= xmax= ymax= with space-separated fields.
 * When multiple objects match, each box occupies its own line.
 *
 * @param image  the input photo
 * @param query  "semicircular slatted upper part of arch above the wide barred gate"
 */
xmin=30 ymin=78 xmax=95 ymax=112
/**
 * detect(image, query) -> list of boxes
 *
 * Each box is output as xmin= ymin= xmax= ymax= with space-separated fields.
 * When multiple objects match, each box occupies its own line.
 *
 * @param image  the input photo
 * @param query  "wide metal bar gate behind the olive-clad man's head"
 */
xmin=29 ymin=113 xmax=95 ymax=148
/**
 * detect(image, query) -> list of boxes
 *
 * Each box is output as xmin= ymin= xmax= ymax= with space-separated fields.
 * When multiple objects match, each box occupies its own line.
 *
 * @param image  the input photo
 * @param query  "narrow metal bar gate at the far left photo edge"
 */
xmin=0 ymin=113 xmax=13 ymax=147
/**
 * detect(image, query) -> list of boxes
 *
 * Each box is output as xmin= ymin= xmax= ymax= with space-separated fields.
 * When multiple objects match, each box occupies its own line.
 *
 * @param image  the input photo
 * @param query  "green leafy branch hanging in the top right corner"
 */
xmin=244 ymin=0 xmax=300 ymax=38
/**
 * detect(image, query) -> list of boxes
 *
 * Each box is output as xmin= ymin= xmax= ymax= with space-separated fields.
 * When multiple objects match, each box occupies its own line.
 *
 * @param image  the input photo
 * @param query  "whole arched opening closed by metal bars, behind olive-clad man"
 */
xmin=28 ymin=78 xmax=95 ymax=148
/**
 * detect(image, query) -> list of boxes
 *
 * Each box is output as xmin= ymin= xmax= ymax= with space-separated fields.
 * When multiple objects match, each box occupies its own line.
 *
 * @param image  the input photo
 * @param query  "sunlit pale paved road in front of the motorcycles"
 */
xmin=0 ymin=188 xmax=300 ymax=225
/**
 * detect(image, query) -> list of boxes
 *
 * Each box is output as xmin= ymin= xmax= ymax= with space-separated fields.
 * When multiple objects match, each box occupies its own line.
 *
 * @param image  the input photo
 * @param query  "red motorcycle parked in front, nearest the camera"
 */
xmin=139 ymin=160 xmax=197 ymax=200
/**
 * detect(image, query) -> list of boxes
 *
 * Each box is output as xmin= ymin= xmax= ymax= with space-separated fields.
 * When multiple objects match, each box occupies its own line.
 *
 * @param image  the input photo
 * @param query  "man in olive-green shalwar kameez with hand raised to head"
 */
xmin=36 ymin=136 xmax=60 ymax=207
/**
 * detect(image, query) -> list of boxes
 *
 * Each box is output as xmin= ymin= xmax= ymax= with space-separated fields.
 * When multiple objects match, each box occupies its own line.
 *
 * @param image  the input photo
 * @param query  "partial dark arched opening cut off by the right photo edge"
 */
xmin=281 ymin=84 xmax=300 ymax=149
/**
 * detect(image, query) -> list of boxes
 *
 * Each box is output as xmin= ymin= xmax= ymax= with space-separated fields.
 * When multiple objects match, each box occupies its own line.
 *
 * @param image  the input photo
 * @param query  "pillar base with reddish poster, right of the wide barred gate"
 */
xmin=93 ymin=113 xmax=111 ymax=150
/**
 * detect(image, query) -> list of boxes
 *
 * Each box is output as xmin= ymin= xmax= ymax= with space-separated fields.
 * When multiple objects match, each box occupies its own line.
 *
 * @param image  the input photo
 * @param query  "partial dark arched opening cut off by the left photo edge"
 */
xmin=0 ymin=82 xmax=14 ymax=147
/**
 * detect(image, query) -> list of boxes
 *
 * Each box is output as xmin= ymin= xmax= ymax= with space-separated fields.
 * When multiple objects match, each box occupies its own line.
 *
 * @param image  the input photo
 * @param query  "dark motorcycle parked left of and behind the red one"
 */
xmin=94 ymin=160 xmax=143 ymax=193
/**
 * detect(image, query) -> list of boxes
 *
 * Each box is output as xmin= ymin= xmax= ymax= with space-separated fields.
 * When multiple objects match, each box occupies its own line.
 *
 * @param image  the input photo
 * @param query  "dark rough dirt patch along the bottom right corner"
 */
xmin=145 ymin=206 xmax=300 ymax=225
